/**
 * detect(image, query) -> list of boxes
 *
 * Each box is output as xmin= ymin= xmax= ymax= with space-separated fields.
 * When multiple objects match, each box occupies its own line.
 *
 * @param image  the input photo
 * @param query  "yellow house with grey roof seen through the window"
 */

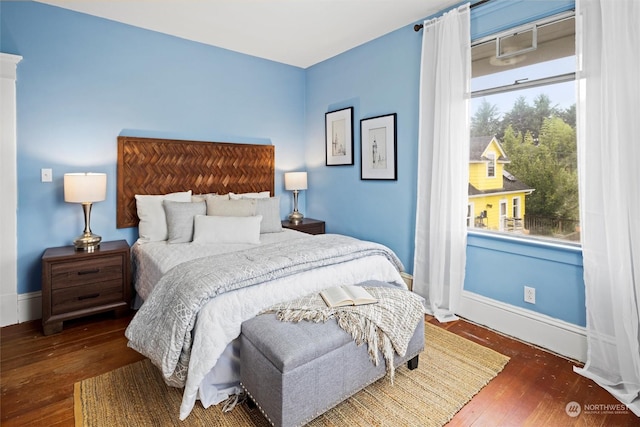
xmin=467 ymin=136 xmax=534 ymax=232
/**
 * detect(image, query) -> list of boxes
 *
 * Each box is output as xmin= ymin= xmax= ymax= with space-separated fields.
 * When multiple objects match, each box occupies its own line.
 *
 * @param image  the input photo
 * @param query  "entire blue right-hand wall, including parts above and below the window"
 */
xmin=306 ymin=0 xmax=585 ymax=326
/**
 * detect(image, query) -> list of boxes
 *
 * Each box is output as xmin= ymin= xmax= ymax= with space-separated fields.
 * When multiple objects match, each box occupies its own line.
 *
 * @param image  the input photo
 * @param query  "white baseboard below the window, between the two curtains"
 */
xmin=456 ymin=291 xmax=587 ymax=362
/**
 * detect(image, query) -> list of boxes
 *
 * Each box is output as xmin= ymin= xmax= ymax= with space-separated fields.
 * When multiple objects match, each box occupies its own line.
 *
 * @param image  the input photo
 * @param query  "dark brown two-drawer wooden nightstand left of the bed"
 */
xmin=42 ymin=240 xmax=131 ymax=335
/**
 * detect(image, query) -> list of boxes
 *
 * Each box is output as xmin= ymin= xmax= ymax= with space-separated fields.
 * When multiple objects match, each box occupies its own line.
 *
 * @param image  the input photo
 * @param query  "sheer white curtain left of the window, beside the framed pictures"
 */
xmin=413 ymin=4 xmax=471 ymax=322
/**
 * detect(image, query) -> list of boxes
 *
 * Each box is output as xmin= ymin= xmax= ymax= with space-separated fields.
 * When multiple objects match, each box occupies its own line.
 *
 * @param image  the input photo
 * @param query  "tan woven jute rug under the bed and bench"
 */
xmin=74 ymin=323 xmax=509 ymax=427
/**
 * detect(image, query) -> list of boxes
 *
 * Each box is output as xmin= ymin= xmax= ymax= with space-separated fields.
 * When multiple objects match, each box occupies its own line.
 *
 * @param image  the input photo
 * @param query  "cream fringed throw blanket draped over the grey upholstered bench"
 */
xmin=263 ymin=286 xmax=424 ymax=383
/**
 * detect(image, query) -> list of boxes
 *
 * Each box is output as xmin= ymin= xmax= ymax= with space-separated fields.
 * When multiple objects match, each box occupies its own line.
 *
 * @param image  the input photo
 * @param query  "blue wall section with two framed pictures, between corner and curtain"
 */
xmin=306 ymin=27 xmax=422 ymax=271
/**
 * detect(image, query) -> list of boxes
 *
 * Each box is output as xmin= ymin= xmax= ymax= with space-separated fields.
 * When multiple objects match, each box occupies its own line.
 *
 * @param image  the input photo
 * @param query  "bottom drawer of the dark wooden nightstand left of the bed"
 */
xmin=51 ymin=279 xmax=123 ymax=314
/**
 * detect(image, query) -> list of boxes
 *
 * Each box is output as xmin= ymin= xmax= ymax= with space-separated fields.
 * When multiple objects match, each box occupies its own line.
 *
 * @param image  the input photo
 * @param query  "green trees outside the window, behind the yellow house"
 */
xmin=471 ymin=95 xmax=578 ymax=219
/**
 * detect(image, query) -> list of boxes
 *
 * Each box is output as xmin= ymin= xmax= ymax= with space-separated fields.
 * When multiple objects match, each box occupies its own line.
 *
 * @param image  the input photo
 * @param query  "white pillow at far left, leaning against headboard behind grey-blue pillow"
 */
xmin=135 ymin=190 xmax=191 ymax=242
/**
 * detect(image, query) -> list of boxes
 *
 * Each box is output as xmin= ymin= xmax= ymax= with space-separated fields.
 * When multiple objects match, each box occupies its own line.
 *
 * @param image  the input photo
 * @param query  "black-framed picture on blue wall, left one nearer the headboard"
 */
xmin=324 ymin=107 xmax=353 ymax=166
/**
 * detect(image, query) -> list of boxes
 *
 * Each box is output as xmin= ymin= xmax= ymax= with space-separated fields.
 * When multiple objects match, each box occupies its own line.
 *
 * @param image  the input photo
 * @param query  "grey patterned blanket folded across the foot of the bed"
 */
xmin=125 ymin=234 xmax=403 ymax=387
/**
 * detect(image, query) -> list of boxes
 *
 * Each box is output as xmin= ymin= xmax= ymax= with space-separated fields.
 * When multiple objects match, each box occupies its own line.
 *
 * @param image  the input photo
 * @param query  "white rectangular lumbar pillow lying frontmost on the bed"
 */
xmin=193 ymin=215 xmax=262 ymax=245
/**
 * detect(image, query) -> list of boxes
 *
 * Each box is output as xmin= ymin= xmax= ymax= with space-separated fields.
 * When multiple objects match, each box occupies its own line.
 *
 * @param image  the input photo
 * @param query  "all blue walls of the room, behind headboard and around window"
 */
xmin=0 ymin=0 xmax=585 ymax=325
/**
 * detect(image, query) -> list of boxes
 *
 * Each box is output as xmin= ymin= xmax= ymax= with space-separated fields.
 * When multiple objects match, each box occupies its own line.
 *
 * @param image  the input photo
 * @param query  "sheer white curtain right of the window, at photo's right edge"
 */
xmin=576 ymin=0 xmax=640 ymax=416
